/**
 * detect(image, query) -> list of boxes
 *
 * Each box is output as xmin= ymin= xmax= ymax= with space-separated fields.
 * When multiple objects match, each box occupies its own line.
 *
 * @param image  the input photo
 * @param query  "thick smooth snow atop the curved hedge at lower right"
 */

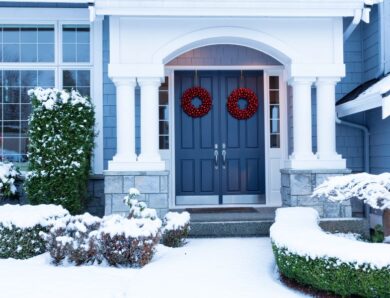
xmin=270 ymin=207 xmax=390 ymax=269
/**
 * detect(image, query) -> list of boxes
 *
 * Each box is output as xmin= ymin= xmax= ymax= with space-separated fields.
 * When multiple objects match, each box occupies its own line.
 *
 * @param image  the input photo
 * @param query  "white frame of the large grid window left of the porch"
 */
xmin=0 ymin=7 xmax=103 ymax=174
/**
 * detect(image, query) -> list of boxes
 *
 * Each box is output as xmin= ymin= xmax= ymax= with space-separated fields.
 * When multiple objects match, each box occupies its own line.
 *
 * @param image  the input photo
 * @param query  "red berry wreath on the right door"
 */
xmin=226 ymin=88 xmax=259 ymax=120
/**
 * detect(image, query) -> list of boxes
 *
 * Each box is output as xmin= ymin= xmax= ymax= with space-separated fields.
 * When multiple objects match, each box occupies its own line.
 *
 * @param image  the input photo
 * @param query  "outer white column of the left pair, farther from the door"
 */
xmin=108 ymin=78 xmax=137 ymax=171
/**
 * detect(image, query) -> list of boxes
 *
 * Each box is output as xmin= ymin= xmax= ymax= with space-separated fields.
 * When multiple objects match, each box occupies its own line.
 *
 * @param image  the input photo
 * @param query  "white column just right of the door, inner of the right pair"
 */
xmin=290 ymin=78 xmax=315 ymax=169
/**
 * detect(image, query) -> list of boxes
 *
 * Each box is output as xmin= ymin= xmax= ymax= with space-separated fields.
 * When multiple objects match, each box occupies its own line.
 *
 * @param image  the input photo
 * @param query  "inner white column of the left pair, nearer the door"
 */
xmin=138 ymin=77 xmax=165 ymax=171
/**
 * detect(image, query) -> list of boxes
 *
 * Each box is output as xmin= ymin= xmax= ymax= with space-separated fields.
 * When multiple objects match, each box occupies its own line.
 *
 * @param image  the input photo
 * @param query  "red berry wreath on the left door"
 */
xmin=181 ymin=87 xmax=212 ymax=118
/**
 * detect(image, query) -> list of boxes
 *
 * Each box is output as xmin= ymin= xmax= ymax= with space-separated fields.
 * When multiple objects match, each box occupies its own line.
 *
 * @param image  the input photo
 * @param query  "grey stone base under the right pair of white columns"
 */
xmin=281 ymin=169 xmax=352 ymax=218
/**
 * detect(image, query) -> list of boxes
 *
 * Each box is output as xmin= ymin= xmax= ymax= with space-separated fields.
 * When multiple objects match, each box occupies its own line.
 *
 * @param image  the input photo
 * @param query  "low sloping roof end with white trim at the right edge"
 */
xmin=337 ymin=75 xmax=390 ymax=119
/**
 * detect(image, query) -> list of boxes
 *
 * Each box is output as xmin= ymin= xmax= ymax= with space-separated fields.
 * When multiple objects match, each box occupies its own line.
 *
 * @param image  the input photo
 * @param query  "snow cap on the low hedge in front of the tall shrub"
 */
xmin=0 ymin=205 xmax=69 ymax=229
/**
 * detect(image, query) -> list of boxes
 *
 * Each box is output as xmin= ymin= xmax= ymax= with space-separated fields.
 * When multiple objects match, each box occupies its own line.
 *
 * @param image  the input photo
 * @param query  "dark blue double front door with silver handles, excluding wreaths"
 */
xmin=175 ymin=71 xmax=265 ymax=205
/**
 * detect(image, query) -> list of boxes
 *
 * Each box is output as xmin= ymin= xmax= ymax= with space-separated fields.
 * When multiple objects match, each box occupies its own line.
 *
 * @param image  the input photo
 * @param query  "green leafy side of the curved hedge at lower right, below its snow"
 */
xmin=272 ymin=244 xmax=390 ymax=297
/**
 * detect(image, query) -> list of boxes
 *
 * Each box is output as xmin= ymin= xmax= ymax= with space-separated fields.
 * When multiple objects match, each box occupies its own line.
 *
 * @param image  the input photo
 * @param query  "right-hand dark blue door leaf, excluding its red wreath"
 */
xmin=220 ymin=71 xmax=265 ymax=204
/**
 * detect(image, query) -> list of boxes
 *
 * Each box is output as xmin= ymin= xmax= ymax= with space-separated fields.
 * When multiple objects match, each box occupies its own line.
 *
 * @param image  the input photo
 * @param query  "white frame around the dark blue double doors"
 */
xmin=160 ymin=65 xmax=288 ymax=209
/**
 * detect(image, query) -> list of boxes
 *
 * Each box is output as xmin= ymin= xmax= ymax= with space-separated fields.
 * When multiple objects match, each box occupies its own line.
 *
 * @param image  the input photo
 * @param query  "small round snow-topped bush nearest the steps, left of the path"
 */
xmin=162 ymin=211 xmax=190 ymax=247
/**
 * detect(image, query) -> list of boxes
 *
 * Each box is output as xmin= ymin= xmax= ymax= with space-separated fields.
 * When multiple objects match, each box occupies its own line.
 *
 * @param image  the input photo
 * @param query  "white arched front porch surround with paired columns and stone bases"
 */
xmin=96 ymin=3 xmax=363 ymax=221
